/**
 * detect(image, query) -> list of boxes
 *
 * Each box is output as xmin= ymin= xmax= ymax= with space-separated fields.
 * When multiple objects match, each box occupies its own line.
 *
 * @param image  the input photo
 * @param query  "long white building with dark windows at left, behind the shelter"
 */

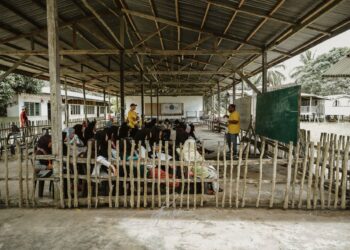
xmin=7 ymin=87 xmax=108 ymax=127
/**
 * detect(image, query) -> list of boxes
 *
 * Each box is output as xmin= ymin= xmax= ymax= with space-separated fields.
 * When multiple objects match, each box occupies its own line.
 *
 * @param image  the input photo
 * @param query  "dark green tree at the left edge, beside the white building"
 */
xmin=0 ymin=72 xmax=43 ymax=116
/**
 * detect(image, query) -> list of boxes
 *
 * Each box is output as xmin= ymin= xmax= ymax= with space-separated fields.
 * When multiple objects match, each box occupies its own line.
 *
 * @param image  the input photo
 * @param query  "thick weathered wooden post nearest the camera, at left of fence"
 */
xmin=46 ymin=0 xmax=62 ymax=203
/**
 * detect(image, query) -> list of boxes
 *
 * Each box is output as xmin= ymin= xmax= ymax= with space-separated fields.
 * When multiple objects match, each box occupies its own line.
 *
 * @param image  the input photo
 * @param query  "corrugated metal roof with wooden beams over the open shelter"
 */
xmin=0 ymin=0 xmax=350 ymax=95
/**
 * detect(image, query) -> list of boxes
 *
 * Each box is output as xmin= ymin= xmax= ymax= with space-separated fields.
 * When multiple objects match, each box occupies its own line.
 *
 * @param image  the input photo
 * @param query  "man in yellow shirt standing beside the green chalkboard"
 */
xmin=225 ymin=104 xmax=241 ymax=157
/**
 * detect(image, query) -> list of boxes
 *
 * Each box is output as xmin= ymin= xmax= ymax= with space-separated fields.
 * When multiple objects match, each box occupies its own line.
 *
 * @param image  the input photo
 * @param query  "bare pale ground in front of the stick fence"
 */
xmin=0 ymin=209 xmax=350 ymax=249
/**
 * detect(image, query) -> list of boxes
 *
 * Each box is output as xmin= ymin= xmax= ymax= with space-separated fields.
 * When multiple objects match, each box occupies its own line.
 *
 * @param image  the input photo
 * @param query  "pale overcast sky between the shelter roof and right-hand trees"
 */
xmin=279 ymin=30 xmax=350 ymax=83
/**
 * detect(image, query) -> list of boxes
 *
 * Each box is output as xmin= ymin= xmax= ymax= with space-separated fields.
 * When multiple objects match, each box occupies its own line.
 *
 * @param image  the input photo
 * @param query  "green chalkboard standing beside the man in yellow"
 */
xmin=255 ymin=86 xmax=300 ymax=145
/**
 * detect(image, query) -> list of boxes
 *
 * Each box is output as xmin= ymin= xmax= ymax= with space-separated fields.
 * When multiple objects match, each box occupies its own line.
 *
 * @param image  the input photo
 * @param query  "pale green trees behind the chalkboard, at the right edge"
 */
xmin=291 ymin=47 xmax=350 ymax=95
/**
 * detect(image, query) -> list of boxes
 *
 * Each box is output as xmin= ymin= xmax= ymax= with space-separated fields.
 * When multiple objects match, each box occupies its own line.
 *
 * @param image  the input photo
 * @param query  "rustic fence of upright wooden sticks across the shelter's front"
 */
xmin=0 ymin=134 xmax=350 ymax=209
